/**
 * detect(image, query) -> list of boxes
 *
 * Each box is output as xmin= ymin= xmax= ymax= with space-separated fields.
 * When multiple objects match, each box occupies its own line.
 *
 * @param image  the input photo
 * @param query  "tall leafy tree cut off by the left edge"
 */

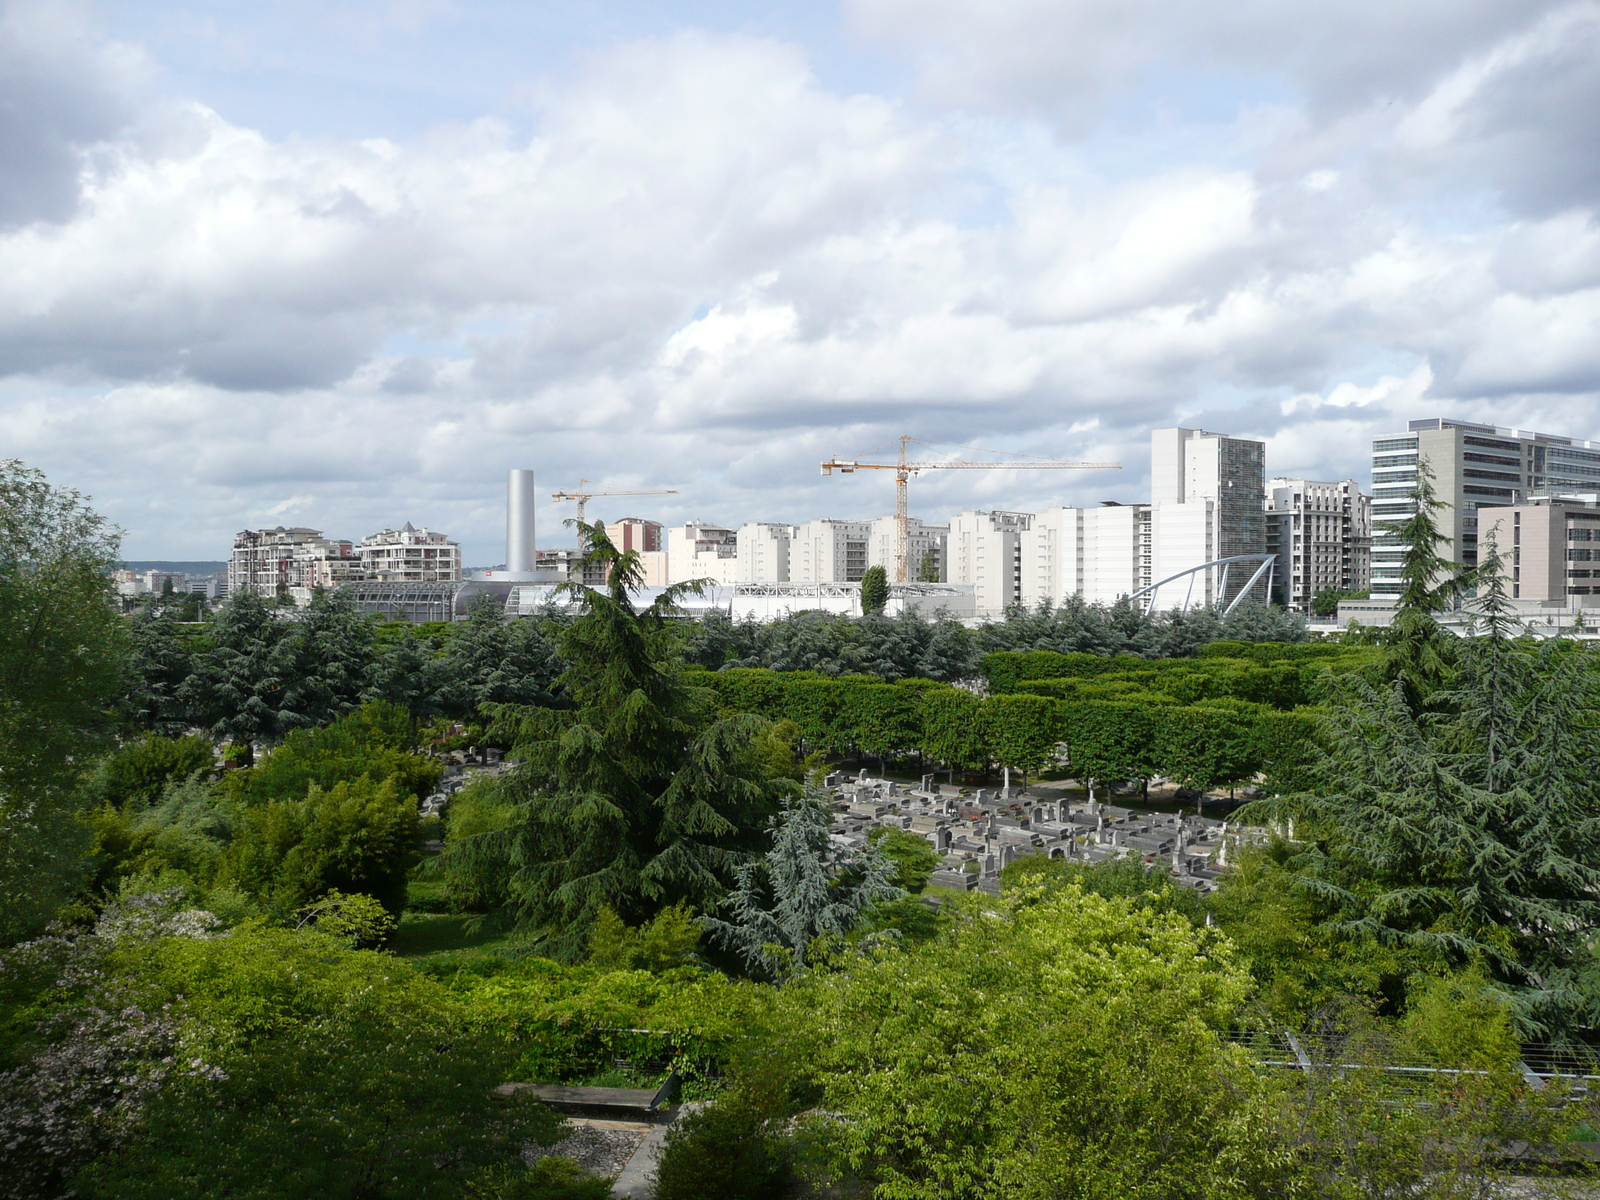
xmin=0 ymin=459 xmax=128 ymax=944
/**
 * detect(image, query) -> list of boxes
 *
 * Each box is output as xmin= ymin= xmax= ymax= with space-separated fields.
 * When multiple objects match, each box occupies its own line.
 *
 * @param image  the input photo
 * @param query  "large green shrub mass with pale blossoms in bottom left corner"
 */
xmin=0 ymin=898 xmax=558 ymax=1200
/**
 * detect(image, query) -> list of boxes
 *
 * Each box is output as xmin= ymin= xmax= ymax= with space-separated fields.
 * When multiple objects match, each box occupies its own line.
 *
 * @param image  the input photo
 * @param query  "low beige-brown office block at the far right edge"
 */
xmin=1477 ymin=491 xmax=1600 ymax=606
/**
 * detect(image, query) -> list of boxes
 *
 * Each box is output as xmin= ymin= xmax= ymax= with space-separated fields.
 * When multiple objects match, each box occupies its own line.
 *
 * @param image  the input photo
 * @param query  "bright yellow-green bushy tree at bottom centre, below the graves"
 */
xmin=707 ymin=886 xmax=1286 ymax=1200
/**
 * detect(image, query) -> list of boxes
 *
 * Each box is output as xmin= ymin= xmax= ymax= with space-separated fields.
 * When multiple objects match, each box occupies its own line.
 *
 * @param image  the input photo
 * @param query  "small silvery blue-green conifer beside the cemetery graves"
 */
xmin=706 ymin=787 xmax=906 ymax=978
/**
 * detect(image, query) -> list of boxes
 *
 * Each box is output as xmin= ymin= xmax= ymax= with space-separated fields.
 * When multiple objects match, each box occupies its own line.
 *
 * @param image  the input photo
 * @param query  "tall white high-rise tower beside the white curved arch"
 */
xmin=1150 ymin=429 xmax=1267 ymax=608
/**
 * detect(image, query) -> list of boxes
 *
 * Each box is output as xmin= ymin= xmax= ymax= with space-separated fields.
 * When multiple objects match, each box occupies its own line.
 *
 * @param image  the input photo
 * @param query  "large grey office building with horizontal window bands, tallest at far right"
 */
xmin=1371 ymin=418 xmax=1600 ymax=603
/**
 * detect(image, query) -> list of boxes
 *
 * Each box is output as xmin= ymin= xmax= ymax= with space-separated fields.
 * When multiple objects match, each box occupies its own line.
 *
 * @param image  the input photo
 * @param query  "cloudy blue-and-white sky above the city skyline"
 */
xmin=0 ymin=0 xmax=1600 ymax=563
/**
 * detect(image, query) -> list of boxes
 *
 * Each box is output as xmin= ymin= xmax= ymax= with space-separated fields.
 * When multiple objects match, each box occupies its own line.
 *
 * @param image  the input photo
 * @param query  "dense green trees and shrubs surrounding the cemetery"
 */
xmin=0 ymin=464 xmax=1600 ymax=1200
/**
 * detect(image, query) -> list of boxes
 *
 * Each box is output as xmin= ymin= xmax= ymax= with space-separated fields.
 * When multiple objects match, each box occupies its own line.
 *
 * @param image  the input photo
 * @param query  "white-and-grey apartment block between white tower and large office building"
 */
xmin=1267 ymin=478 xmax=1373 ymax=614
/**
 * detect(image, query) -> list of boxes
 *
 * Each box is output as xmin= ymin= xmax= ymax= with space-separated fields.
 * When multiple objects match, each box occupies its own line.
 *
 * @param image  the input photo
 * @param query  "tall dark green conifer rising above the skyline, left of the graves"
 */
xmin=435 ymin=522 xmax=789 ymax=958
